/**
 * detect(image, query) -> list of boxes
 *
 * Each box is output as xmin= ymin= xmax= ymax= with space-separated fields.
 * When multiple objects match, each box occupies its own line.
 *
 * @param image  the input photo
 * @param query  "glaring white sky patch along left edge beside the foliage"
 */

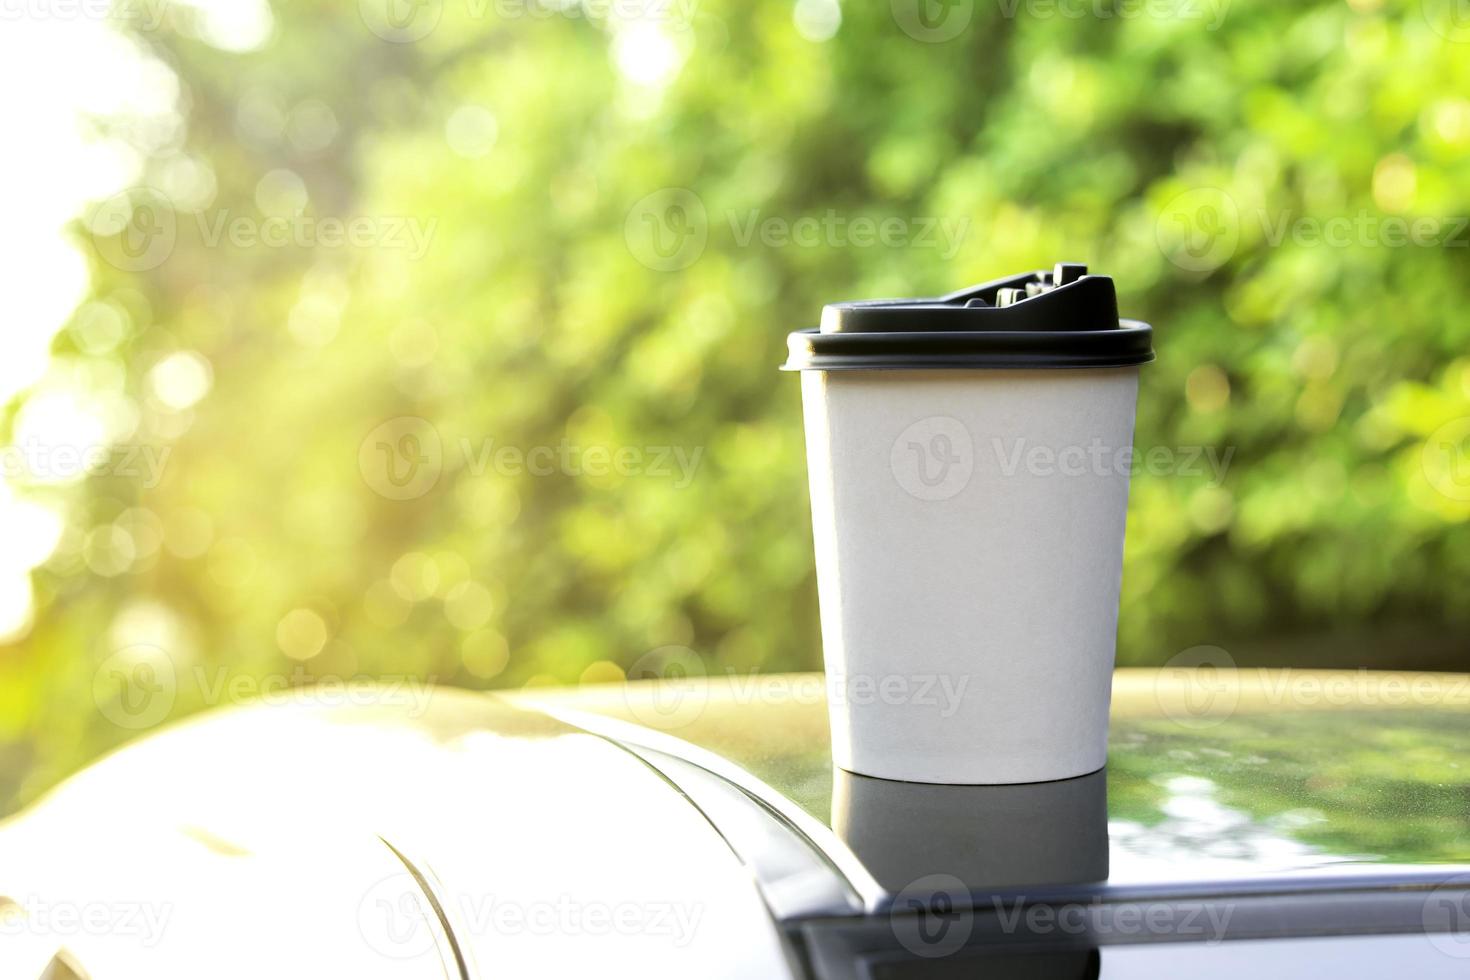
xmin=0 ymin=15 xmax=182 ymax=644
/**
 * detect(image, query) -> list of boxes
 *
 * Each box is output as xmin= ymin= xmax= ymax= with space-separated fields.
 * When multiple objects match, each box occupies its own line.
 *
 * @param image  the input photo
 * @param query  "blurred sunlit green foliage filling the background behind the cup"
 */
xmin=0 ymin=0 xmax=1470 ymax=810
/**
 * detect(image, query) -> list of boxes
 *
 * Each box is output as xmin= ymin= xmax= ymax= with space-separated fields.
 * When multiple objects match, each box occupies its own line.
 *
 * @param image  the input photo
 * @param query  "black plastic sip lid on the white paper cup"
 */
xmin=781 ymin=263 xmax=1154 ymax=370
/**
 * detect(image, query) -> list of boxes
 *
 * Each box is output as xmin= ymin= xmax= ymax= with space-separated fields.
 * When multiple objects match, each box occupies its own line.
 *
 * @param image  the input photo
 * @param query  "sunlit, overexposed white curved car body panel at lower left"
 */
xmin=0 ymin=691 xmax=789 ymax=980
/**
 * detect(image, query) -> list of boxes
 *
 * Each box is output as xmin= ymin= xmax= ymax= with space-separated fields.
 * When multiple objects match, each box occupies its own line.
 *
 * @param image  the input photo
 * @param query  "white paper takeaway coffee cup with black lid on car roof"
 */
xmin=784 ymin=263 xmax=1154 ymax=783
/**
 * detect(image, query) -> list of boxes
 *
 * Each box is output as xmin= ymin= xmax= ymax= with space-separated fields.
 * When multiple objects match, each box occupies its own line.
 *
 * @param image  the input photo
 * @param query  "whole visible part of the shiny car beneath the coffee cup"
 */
xmin=0 ymin=671 xmax=1470 ymax=980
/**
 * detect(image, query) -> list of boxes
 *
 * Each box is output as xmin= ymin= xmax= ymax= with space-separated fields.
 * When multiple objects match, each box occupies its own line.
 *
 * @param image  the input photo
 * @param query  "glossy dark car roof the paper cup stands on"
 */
xmin=516 ymin=669 xmax=1470 ymax=893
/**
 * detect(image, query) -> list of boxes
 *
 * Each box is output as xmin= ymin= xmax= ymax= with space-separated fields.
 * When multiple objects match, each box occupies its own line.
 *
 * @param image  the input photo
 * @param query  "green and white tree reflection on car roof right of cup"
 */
xmin=1108 ymin=710 xmax=1470 ymax=867
